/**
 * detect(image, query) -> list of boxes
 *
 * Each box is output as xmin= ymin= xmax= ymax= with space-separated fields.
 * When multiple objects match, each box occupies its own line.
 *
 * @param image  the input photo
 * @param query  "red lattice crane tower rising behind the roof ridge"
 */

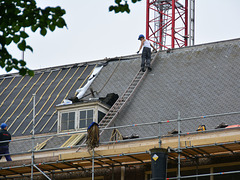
xmin=146 ymin=0 xmax=195 ymax=49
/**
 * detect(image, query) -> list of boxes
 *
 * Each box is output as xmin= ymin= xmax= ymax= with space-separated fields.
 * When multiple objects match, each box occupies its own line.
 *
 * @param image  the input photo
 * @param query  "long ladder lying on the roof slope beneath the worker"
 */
xmin=99 ymin=53 xmax=158 ymax=135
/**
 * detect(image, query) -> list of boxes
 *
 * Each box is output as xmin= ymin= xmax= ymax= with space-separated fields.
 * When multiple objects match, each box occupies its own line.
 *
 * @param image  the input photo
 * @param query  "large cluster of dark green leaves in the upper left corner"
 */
xmin=0 ymin=0 xmax=67 ymax=76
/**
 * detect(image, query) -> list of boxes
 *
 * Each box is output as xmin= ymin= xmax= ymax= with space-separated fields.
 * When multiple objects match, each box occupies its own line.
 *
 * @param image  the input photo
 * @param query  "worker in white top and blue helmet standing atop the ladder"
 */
xmin=137 ymin=34 xmax=157 ymax=72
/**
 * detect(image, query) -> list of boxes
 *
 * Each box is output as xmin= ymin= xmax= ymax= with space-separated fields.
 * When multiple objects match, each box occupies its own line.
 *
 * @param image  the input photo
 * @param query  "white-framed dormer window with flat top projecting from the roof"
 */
xmin=56 ymin=101 xmax=109 ymax=132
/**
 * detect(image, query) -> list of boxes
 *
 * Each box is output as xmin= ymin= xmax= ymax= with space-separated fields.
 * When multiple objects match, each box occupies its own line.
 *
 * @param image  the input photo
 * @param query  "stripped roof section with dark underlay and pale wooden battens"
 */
xmin=0 ymin=63 xmax=96 ymax=136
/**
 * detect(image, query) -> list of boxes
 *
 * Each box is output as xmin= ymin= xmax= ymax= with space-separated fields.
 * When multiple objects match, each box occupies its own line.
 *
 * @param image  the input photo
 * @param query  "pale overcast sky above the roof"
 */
xmin=0 ymin=0 xmax=240 ymax=74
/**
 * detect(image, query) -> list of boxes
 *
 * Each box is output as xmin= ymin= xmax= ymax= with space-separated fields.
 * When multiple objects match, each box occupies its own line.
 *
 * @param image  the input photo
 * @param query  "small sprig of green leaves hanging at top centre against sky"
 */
xmin=109 ymin=0 xmax=141 ymax=13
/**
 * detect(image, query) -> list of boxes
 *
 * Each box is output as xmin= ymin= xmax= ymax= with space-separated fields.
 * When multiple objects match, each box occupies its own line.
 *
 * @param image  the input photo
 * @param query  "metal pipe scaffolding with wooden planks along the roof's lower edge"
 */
xmin=0 ymin=109 xmax=240 ymax=179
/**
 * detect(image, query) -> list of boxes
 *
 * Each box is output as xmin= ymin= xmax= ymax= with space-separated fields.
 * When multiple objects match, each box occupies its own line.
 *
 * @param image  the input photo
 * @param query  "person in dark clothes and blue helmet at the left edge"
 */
xmin=0 ymin=123 xmax=12 ymax=161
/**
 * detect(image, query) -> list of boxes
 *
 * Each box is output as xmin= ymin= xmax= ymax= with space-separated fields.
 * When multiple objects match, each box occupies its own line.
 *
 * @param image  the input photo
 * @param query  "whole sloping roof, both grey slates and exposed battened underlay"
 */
xmin=0 ymin=39 xmax=240 ymax=152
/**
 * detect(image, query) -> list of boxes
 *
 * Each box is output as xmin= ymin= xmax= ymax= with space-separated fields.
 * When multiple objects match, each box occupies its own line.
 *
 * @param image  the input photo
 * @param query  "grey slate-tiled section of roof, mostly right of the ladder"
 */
xmin=99 ymin=39 xmax=240 ymax=140
